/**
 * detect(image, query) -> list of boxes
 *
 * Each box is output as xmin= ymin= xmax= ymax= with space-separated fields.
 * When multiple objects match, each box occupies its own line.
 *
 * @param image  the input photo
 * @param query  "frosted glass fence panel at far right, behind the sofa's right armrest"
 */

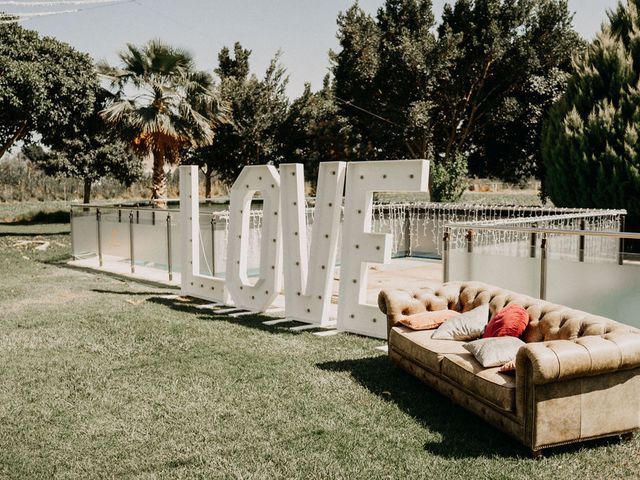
xmin=547 ymin=255 xmax=640 ymax=327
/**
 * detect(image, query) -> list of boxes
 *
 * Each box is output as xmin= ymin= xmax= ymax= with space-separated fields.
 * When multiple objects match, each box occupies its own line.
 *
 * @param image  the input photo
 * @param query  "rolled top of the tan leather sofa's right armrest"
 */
xmin=516 ymin=333 xmax=640 ymax=385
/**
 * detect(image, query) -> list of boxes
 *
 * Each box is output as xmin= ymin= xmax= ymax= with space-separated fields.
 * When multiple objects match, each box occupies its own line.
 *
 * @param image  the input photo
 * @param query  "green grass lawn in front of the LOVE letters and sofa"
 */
xmin=0 ymin=227 xmax=640 ymax=479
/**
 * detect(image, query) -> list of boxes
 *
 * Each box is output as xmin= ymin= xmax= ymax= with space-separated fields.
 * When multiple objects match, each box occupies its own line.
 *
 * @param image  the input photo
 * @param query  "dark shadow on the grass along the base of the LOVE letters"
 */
xmin=148 ymin=296 xmax=303 ymax=335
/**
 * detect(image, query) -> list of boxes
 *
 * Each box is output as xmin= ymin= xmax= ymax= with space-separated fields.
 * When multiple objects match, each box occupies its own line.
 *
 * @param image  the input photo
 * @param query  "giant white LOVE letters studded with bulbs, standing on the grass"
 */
xmin=180 ymin=160 xmax=429 ymax=338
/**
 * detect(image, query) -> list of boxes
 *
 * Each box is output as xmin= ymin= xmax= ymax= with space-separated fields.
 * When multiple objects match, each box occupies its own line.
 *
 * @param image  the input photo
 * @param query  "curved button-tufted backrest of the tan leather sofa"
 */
xmin=379 ymin=282 xmax=639 ymax=342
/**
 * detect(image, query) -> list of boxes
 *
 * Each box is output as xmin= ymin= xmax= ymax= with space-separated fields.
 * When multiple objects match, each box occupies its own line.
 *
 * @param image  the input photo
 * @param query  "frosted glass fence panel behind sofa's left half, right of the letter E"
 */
xmin=449 ymin=250 xmax=540 ymax=298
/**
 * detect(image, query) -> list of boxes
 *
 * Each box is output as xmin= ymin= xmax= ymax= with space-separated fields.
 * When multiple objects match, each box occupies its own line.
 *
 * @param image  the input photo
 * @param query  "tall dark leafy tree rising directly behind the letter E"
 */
xmin=331 ymin=0 xmax=435 ymax=160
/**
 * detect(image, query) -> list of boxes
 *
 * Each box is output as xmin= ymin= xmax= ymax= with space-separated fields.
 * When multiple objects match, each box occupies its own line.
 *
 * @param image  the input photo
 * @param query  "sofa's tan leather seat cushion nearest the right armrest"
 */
xmin=442 ymin=352 xmax=516 ymax=411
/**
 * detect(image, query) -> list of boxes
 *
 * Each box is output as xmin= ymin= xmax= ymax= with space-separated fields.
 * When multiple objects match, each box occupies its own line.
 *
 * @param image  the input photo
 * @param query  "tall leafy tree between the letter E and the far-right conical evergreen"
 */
xmin=434 ymin=0 xmax=582 ymax=181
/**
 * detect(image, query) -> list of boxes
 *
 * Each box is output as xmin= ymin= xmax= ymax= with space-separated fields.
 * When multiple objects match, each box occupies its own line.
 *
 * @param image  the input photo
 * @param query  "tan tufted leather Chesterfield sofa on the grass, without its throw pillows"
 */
xmin=378 ymin=282 xmax=640 ymax=455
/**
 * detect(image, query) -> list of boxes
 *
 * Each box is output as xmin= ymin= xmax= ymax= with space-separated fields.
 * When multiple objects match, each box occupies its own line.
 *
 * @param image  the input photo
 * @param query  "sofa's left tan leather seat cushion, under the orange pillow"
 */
xmin=389 ymin=326 xmax=467 ymax=373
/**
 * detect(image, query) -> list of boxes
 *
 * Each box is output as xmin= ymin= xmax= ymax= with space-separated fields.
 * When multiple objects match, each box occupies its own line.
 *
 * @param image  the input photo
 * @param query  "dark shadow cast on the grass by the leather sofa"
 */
xmin=317 ymin=355 xmax=632 ymax=459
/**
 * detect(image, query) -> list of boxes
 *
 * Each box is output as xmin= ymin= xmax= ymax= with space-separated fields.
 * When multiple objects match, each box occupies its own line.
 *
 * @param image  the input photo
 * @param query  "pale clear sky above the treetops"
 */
xmin=0 ymin=0 xmax=618 ymax=98
